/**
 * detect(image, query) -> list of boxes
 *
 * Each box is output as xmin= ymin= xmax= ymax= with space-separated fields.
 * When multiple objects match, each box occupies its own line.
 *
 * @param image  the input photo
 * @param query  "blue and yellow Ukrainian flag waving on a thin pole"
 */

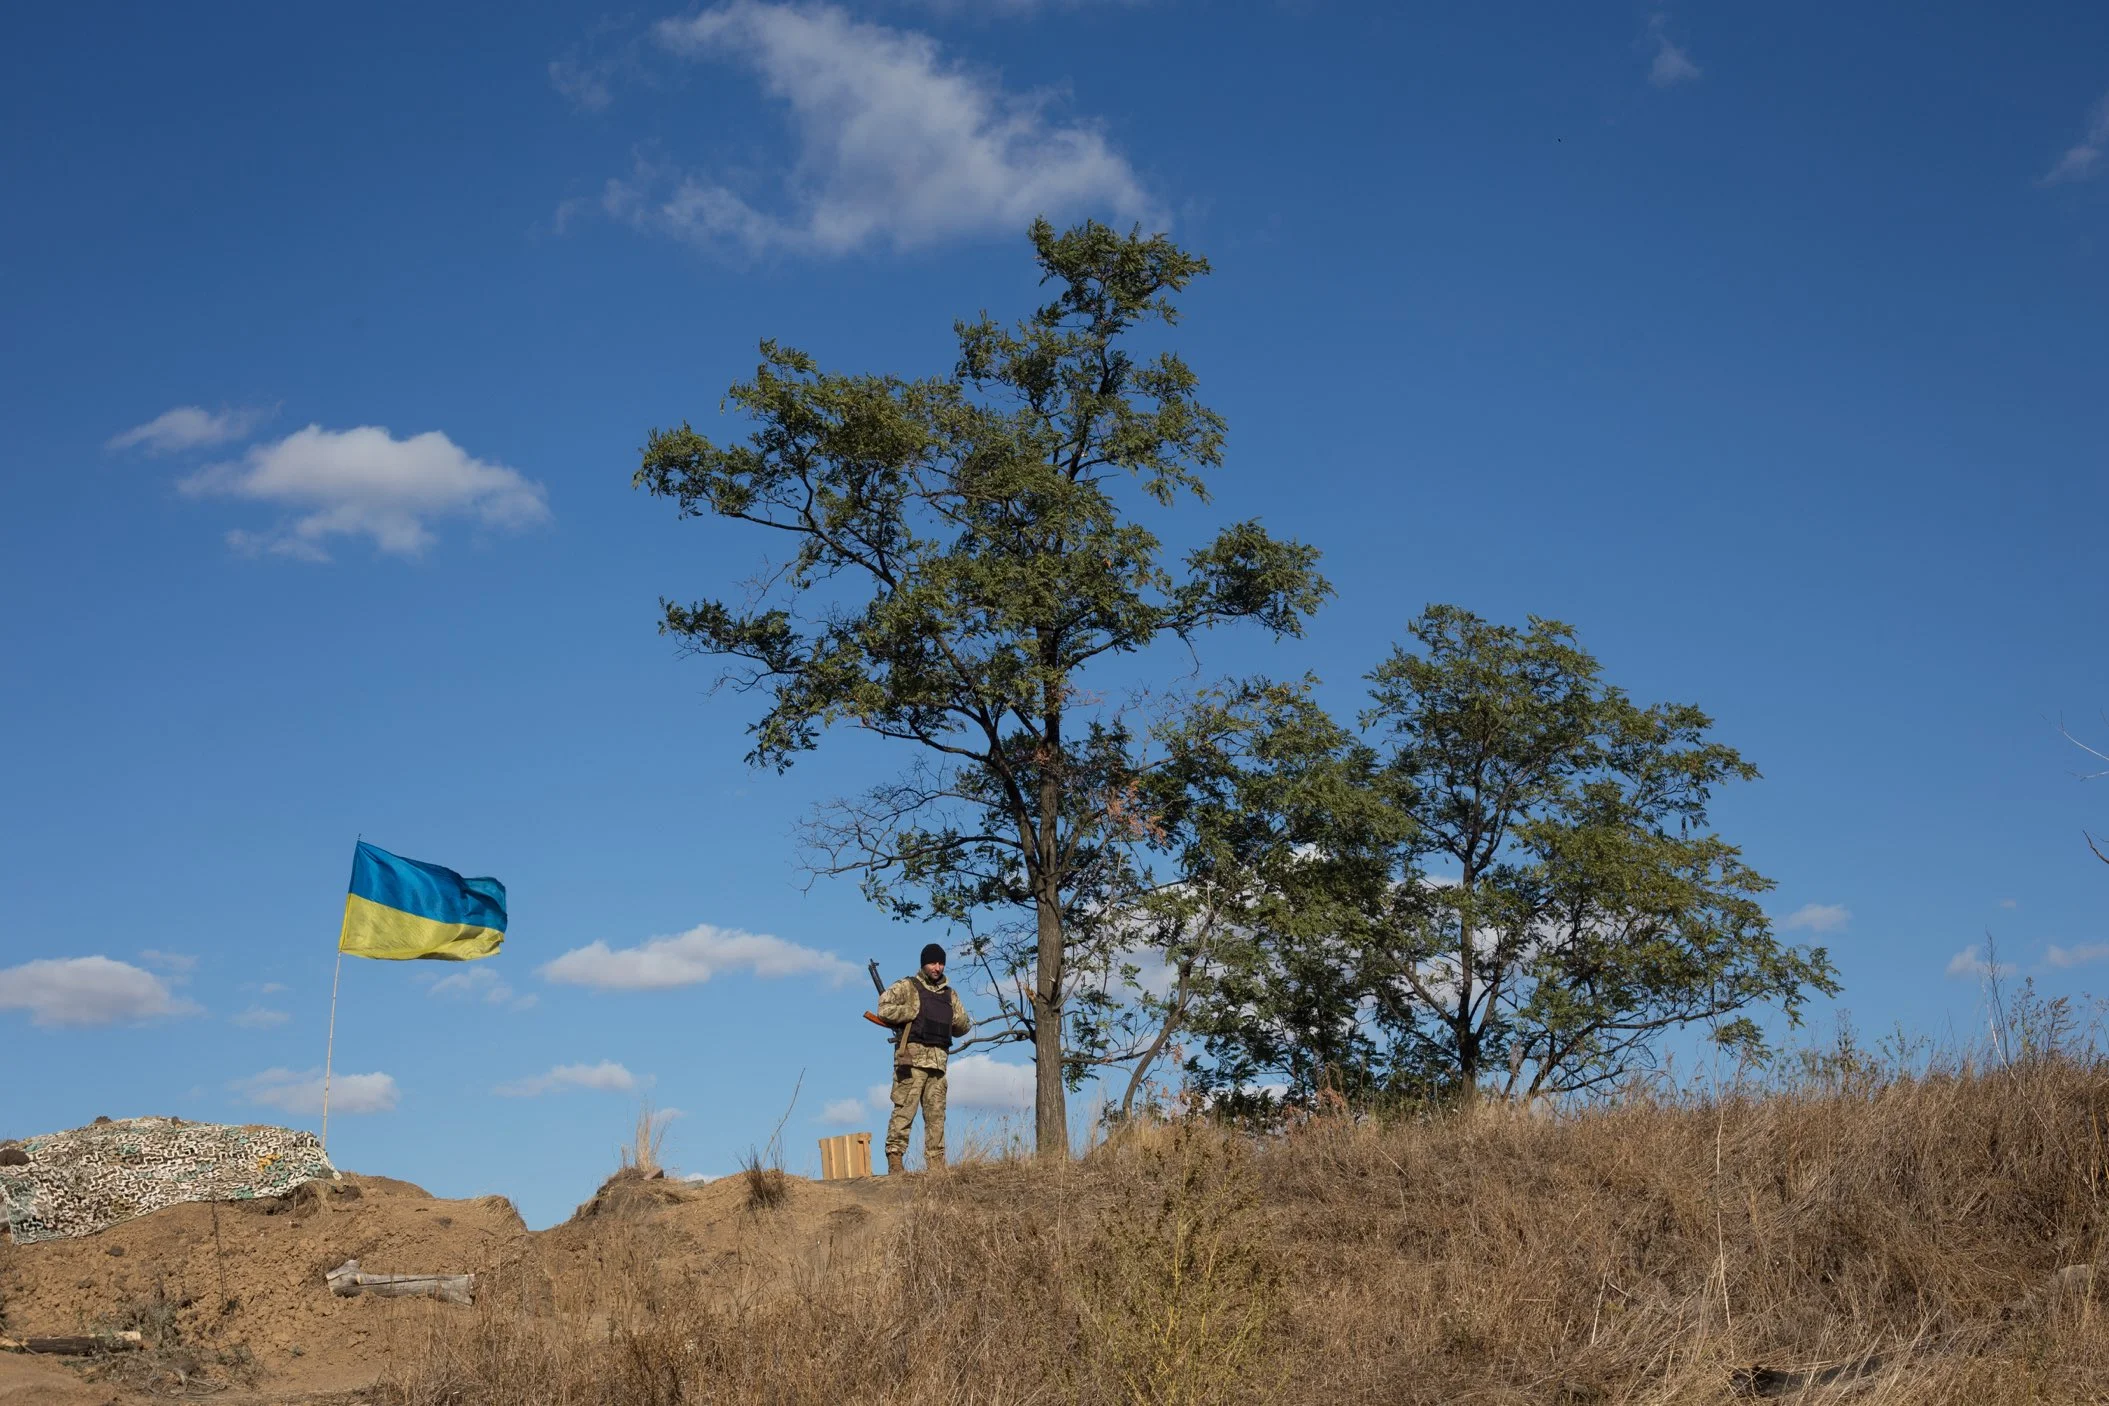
xmin=337 ymin=841 xmax=506 ymax=961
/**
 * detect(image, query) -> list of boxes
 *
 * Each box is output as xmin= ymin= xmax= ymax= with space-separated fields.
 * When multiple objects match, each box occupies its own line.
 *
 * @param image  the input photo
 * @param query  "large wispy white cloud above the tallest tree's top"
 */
xmin=601 ymin=0 xmax=1156 ymax=255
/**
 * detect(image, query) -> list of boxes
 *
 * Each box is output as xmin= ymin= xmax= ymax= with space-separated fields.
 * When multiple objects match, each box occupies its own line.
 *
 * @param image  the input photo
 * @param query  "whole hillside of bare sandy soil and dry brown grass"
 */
xmin=0 ymin=1060 xmax=2109 ymax=1406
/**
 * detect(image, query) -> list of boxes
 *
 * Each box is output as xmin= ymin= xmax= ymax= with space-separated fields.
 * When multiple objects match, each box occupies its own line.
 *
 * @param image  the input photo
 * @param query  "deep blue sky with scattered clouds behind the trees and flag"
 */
xmin=0 ymin=0 xmax=2109 ymax=1225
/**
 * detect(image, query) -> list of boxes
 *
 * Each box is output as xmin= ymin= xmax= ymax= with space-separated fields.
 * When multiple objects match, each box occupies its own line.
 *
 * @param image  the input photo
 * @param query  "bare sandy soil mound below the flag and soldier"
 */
xmin=0 ymin=1172 xmax=905 ymax=1406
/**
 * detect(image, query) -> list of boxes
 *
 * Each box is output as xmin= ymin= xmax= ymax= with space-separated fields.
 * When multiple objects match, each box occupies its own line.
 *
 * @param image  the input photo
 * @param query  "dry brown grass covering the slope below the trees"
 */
xmin=388 ymin=1054 xmax=2109 ymax=1406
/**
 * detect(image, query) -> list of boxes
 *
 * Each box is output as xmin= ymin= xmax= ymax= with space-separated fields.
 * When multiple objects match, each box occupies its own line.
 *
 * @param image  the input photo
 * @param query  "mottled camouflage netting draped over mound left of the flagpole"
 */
xmin=0 ymin=1117 xmax=337 ymax=1246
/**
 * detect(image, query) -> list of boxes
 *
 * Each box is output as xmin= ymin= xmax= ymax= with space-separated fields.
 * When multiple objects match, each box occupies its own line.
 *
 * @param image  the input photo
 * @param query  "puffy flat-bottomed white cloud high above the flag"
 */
xmin=179 ymin=426 xmax=548 ymax=561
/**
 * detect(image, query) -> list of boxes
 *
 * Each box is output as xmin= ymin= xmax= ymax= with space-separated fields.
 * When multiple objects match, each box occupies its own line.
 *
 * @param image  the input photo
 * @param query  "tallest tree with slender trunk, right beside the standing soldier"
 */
xmin=635 ymin=221 xmax=1327 ymax=1155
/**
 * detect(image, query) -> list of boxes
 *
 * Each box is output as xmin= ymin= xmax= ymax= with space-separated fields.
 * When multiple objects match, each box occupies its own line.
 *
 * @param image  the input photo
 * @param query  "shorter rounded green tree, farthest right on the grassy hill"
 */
xmin=1208 ymin=605 xmax=1837 ymax=1100
